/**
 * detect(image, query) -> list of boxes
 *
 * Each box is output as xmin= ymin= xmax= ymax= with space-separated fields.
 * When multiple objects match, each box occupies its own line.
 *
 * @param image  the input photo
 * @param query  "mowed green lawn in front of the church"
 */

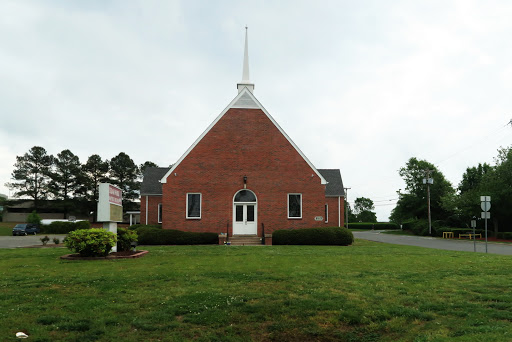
xmin=0 ymin=240 xmax=512 ymax=342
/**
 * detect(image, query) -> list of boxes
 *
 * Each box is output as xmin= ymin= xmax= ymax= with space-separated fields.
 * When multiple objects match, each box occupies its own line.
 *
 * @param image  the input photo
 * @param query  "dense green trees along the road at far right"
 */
xmin=390 ymin=147 xmax=512 ymax=233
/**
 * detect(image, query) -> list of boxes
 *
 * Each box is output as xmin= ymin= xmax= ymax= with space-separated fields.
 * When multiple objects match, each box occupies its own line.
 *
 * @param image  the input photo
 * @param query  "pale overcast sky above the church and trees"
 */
xmin=0 ymin=0 xmax=512 ymax=220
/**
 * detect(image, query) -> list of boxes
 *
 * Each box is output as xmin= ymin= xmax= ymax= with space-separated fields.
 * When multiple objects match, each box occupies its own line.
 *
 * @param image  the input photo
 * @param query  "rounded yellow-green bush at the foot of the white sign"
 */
xmin=64 ymin=228 xmax=117 ymax=257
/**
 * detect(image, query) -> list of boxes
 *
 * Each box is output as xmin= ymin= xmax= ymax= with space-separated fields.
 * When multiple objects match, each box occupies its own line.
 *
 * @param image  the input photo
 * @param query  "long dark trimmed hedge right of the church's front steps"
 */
xmin=272 ymin=227 xmax=354 ymax=246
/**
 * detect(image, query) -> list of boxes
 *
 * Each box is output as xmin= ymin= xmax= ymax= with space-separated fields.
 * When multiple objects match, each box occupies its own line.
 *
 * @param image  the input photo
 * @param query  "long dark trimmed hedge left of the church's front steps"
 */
xmin=136 ymin=226 xmax=219 ymax=245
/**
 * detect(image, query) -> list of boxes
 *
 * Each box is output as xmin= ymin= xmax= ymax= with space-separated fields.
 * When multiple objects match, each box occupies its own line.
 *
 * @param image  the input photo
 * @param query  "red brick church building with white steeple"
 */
xmin=140 ymin=31 xmax=344 ymax=237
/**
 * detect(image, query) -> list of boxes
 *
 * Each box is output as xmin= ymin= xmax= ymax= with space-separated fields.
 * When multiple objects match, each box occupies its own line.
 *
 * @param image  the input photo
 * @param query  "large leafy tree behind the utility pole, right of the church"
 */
xmin=390 ymin=158 xmax=455 ymax=222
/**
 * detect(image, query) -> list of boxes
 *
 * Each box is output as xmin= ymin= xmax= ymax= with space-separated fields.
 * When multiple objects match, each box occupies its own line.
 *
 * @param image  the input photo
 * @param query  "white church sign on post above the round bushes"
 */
xmin=98 ymin=183 xmax=123 ymax=252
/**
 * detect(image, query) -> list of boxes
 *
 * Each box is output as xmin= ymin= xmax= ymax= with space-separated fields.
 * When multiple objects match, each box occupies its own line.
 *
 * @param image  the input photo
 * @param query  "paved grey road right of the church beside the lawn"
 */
xmin=353 ymin=230 xmax=512 ymax=255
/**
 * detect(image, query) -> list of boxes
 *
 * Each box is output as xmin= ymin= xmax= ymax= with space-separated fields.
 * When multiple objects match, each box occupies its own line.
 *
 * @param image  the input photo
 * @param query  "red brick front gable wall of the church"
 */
xmin=162 ymin=108 xmax=334 ymax=235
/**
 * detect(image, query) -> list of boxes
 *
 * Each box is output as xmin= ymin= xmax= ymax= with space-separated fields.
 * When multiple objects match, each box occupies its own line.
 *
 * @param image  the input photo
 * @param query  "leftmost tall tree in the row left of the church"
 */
xmin=6 ymin=146 xmax=53 ymax=209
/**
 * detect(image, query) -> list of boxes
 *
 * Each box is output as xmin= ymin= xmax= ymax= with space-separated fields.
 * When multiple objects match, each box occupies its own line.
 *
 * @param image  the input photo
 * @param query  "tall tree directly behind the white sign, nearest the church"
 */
xmin=110 ymin=152 xmax=140 ymax=206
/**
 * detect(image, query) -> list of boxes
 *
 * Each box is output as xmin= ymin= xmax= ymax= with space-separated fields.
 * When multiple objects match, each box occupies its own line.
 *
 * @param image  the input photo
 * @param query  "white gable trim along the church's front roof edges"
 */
xmin=160 ymin=87 xmax=327 ymax=184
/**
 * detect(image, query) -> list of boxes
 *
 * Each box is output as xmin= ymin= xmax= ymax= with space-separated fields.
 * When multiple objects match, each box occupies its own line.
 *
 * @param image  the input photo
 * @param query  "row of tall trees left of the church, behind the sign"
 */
xmin=5 ymin=146 xmax=157 ymax=215
